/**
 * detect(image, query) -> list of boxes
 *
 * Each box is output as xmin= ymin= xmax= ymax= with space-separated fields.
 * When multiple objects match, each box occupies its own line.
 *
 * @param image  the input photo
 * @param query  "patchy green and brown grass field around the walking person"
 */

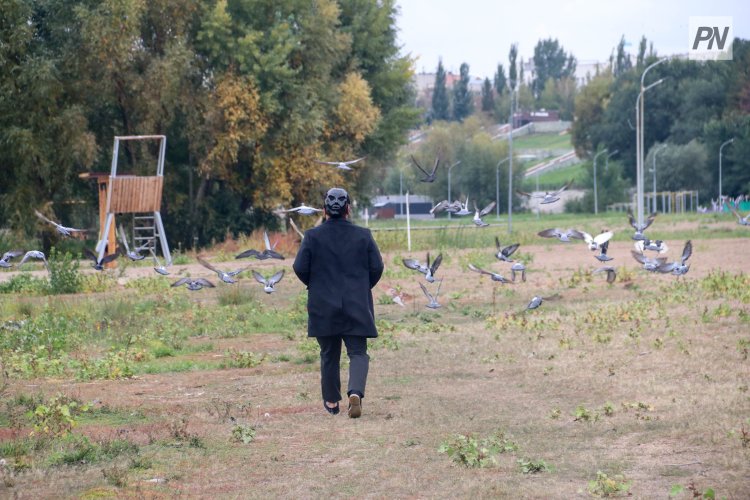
xmin=0 ymin=214 xmax=750 ymax=499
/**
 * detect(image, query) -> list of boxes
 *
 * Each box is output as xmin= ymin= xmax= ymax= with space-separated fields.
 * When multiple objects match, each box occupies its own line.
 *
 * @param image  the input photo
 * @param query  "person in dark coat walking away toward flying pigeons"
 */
xmin=293 ymin=188 xmax=383 ymax=418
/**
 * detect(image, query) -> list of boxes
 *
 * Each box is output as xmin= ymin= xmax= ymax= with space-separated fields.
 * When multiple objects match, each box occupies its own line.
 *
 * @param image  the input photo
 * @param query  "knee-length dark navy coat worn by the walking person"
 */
xmin=293 ymin=219 xmax=383 ymax=337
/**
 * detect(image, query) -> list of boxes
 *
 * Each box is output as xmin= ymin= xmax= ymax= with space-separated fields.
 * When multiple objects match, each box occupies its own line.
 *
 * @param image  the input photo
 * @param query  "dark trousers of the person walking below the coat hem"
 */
xmin=316 ymin=335 xmax=370 ymax=403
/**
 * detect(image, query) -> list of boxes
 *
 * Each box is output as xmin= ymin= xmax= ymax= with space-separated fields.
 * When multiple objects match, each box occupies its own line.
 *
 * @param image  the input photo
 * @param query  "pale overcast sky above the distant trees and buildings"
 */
xmin=397 ymin=0 xmax=750 ymax=79
